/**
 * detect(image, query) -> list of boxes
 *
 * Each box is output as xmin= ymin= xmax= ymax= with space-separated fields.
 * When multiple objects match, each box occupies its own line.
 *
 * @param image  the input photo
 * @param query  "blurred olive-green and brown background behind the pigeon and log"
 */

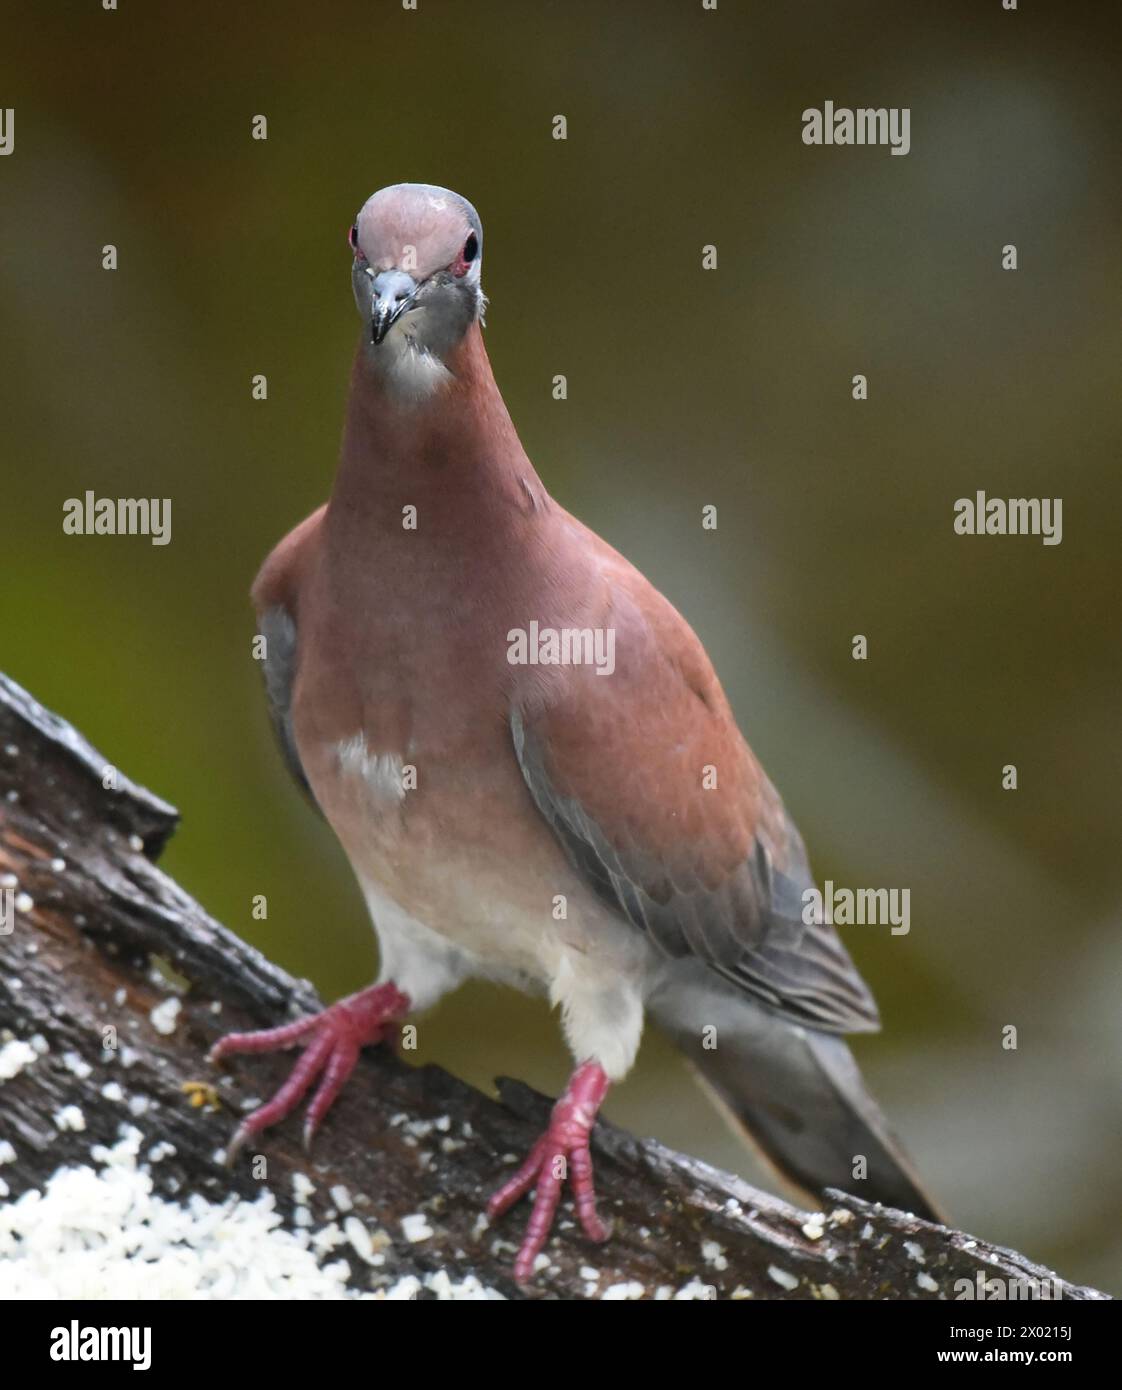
xmin=0 ymin=0 xmax=1122 ymax=1293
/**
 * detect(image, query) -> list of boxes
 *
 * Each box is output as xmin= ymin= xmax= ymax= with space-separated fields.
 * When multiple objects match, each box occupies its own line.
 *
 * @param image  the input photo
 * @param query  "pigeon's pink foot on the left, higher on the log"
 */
xmin=207 ymin=984 xmax=409 ymax=1163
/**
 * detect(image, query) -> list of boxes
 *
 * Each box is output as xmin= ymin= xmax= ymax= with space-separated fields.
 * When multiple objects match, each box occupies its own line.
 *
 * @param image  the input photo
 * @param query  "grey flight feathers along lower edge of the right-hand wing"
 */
xmin=510 ymin=713 xmax=880 ymax=1033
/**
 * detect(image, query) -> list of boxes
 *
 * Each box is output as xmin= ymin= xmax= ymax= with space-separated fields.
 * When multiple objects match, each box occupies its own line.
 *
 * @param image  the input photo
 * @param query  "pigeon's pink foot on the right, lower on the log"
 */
xmin=487 ymin=1062 xmax=609 ymax=1284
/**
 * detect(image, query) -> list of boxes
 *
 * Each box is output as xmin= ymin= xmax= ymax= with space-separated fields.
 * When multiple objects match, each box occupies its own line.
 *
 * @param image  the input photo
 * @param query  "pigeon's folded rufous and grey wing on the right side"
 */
xmin=512 ymin=552 xmax=879 ymax=1033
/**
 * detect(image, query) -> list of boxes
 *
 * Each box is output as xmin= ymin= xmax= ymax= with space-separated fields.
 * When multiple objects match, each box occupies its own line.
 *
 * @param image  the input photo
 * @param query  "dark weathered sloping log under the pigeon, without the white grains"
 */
xmin=0 ymin=677 xmax=1105 ymax=1298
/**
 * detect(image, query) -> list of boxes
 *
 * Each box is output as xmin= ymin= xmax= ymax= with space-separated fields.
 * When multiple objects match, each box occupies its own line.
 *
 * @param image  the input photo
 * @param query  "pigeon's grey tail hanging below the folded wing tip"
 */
xmin=651 ymin=991 xmax=944 ymax=1222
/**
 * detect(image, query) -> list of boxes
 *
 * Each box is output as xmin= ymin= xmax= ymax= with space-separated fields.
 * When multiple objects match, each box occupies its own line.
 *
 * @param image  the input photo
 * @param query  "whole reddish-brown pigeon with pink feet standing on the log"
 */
xmin=214 ymin=183 xmax=934 ymax=1279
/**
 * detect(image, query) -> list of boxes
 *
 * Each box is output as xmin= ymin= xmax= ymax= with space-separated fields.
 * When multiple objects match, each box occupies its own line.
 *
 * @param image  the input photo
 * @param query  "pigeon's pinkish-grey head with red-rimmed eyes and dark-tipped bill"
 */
xmin=348 ymin=183 xmax=484 ymax=384
